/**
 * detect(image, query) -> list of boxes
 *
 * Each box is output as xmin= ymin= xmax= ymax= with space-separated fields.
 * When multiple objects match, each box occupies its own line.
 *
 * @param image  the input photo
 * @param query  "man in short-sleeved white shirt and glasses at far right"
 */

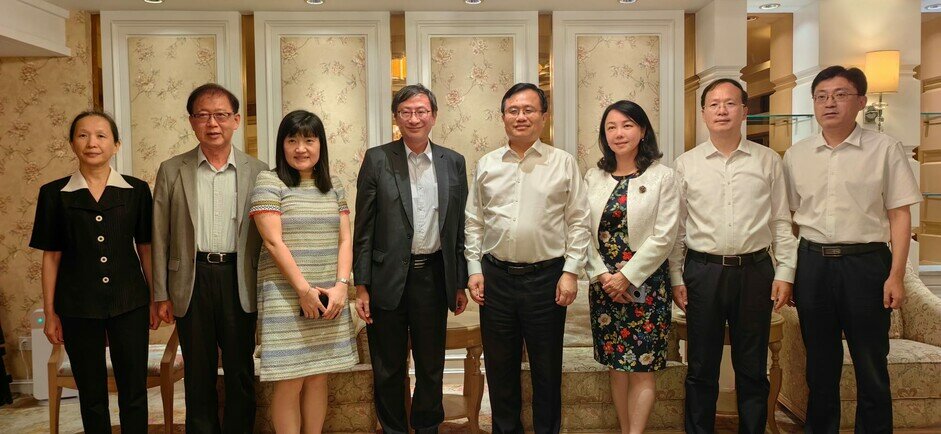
xmin=784 ymin=66 xmax=921 ymax=433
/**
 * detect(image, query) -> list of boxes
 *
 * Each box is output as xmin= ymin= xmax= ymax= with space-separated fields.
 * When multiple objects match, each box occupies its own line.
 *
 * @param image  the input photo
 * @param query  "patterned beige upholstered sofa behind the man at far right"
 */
xmin=778 ymin=266 xmax=941 ymax=432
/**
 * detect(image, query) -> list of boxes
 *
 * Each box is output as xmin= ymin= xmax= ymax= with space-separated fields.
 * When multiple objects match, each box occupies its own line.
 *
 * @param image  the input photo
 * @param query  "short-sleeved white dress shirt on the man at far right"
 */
xmin=784 ymin=124 xmax=921 ymax=244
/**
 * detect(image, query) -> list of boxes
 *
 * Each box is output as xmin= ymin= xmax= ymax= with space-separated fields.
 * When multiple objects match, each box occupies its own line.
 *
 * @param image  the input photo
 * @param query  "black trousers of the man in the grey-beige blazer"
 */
xmin=176 ymin=262 xmax=258 ymax=434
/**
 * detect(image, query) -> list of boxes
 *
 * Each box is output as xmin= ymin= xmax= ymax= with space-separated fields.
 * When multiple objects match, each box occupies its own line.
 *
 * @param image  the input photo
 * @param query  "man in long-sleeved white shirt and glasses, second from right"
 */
xmin=670 ymin=79 xmax=797 ymax=433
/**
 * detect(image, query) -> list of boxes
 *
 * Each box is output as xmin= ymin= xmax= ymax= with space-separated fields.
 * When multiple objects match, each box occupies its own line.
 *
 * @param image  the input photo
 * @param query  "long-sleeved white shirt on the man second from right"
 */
xmin=670 ymin=137 xmax=797 ymax=286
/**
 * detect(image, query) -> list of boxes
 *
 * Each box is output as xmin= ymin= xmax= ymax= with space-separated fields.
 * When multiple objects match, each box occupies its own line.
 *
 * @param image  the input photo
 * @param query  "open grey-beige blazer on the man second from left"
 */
xmin=151 ymin=147 xmax=268 ymax=317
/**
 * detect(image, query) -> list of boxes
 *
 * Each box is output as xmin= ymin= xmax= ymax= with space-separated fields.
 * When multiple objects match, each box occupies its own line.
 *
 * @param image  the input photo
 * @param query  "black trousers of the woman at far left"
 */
xmin=59 ymin=306 xmax=150 ymax=434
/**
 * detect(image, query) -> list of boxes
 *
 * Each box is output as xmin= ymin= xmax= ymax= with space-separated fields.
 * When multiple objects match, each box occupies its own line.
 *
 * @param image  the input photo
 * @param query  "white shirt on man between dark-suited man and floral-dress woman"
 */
xmin=464 ymin=140 xmax=591 ymax=274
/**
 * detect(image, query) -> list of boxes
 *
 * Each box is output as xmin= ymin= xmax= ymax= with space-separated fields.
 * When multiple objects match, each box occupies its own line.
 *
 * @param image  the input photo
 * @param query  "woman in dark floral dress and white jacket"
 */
xmin=585 ymin=100 xmax=679 ymax=433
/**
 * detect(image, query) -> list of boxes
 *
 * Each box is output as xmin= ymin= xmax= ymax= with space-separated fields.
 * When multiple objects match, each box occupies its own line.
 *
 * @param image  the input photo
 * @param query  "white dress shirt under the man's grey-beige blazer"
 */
xmin=196 ymin=148 xmax=238 ymax=252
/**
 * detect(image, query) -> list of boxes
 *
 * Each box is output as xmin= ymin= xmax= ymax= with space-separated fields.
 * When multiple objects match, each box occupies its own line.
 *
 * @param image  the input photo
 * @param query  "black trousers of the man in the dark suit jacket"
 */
xmin=367 ymin=254 xmax=448 ymax=434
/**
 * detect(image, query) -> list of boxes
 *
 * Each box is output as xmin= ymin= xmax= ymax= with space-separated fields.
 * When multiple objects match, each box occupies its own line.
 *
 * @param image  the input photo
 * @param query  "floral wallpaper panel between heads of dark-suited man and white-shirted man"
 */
xmin=426 ymin=36 xmax=516 ymax=176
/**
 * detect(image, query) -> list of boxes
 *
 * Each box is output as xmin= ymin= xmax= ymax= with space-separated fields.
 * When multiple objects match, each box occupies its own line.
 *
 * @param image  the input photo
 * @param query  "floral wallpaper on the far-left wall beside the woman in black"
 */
xmin=0 ymin=12 xmax=92 ymax=379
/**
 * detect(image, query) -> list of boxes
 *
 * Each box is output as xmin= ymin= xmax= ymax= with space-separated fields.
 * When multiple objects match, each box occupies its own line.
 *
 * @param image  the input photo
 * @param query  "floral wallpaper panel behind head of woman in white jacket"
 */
xmin=576 ymin=36 xmax=663 ymax=173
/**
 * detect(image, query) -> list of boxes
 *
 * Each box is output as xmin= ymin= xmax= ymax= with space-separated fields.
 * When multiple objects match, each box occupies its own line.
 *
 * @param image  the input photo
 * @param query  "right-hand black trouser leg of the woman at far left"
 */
xmin=106 ymin=306 xmax=150 ymax=433
